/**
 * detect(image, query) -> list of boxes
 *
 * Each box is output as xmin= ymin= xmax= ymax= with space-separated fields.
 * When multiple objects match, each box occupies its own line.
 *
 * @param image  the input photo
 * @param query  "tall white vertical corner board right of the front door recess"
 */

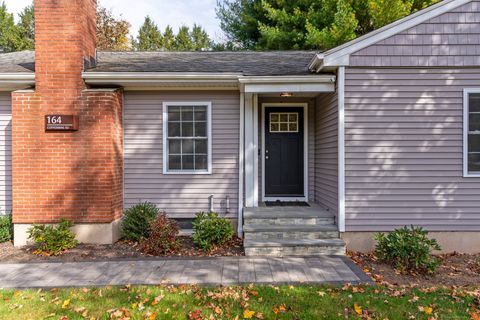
xmin=337 ymin=66 xmax=345 ymax=232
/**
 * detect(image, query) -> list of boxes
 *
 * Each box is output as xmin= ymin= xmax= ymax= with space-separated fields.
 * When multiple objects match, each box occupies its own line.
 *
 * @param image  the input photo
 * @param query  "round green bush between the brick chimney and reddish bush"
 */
xmin=121 ymin=202 xmax=160 ymax=241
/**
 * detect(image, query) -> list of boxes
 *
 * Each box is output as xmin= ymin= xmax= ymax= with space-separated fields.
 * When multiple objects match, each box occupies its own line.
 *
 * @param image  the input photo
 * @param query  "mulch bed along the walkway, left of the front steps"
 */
xmin=0 ymin=236 xmax=244 ymax=263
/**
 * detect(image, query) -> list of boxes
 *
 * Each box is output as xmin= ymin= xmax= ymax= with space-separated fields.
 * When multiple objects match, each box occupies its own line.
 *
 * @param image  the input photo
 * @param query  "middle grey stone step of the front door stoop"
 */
xmin=243 ymin=224 xmax=339 ymax=240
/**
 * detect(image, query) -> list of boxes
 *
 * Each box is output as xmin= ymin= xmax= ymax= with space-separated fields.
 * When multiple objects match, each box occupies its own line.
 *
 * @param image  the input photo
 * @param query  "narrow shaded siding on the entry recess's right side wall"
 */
xmin=315 ymin=93 xmax=338 ymax=214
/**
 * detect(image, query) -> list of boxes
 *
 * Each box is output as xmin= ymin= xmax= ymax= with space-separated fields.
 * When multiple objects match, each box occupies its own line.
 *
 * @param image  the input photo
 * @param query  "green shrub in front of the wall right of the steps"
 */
xmin=375 ymin=226 xmax=441 ymax=273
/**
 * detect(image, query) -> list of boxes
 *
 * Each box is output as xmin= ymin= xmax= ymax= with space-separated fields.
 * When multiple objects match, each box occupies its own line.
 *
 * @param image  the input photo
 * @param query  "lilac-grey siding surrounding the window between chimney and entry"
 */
xmin=124 ymin=91 xmax=240 ymax=218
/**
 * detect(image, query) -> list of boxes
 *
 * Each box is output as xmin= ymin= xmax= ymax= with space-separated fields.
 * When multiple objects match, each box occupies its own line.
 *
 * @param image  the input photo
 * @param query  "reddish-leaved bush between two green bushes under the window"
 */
xmin=140 ymin=213 xmax=180 ymax=255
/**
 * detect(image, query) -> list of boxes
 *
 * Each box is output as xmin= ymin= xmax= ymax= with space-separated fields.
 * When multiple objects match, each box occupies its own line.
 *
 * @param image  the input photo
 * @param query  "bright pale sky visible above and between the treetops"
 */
xmin=4 ymin=0 xmax=224 ymax=41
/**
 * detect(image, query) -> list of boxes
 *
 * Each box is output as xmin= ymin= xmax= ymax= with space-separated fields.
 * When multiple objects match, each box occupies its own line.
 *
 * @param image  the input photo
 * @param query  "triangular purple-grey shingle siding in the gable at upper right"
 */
xmin=350 ymin=1 xmax=480 ymax=67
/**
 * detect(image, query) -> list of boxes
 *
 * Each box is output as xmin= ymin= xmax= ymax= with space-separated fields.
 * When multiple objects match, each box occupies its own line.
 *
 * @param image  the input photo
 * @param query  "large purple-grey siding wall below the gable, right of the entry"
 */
xmin=345 ymin=68 xmax=480 ymax=231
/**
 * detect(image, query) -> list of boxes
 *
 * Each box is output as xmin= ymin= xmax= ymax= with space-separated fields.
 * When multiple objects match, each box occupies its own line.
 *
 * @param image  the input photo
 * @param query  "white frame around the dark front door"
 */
xmin=261 ymin=102 xmax=308 ymax=202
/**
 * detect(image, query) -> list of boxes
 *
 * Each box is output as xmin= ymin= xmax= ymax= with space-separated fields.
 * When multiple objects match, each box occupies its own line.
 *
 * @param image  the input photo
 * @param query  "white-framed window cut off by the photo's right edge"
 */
xmin=463 ymin=88 xmax=480 ymax=177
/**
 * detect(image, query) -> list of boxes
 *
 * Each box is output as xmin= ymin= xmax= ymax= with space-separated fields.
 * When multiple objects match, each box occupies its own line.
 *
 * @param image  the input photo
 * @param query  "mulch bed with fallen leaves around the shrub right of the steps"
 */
xmin=348 ymin=252 xmax=480 ymax=287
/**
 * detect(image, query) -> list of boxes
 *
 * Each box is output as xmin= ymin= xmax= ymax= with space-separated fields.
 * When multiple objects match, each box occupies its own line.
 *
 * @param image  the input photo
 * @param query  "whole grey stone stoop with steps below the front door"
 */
xmin=243 ymin=206 xmax=345 ymax=257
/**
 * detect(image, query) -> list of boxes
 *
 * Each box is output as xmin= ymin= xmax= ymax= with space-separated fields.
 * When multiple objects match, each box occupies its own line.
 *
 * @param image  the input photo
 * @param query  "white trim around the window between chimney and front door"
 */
xmin=162 ymin=101 xmax=213 ymax=175
